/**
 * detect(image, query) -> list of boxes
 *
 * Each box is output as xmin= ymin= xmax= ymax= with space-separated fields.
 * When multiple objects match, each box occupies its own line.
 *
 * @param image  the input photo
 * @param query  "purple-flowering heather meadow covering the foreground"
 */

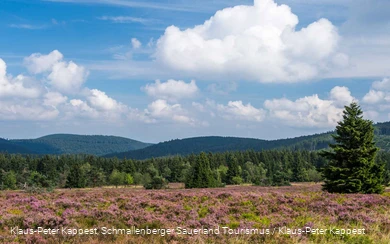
xmin=0 ymin=183 xmax=390 ymax=244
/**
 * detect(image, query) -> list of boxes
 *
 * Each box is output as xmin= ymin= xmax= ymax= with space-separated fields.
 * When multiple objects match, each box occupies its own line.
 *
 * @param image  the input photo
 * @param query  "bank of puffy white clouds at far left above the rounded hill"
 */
xmin=0 ymin=50 xmax=137 ymax=123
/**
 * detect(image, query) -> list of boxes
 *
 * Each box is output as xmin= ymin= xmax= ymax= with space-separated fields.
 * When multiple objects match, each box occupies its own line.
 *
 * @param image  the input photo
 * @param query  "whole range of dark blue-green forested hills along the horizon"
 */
xmin=0 ymin=122 xmax=390 ymax=159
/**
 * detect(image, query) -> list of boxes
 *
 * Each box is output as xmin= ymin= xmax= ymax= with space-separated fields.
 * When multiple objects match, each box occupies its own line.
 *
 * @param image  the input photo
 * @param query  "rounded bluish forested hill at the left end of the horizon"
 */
xmin=0 ymin=134 xmax=151 ymax=156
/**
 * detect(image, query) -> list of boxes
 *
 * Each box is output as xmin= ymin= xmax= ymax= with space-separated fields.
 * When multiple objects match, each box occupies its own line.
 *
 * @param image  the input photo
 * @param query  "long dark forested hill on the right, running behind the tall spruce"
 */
xmin=105 ymin=122 xmax=390 ymax=159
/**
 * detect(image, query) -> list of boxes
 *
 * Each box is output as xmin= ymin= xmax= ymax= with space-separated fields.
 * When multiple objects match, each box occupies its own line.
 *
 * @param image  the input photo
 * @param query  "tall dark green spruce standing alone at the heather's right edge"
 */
xmin=321 ymin=102 xmax=384 ymax=193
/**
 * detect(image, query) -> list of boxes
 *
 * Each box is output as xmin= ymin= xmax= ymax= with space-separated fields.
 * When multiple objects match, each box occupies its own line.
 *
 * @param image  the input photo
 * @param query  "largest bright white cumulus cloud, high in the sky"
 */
xmin=155 ymin=0 xmax=347 ymax=82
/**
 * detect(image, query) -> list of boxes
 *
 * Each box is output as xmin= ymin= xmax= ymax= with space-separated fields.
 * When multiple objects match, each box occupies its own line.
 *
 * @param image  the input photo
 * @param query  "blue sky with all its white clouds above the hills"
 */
xmin=0 ymin=0 xmax=390 ymax=142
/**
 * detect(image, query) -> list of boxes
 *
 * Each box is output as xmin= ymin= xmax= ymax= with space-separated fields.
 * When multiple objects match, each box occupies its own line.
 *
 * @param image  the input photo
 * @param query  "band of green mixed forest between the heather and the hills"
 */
xmin=0 ymin=150 xmax=390 ymax=189
